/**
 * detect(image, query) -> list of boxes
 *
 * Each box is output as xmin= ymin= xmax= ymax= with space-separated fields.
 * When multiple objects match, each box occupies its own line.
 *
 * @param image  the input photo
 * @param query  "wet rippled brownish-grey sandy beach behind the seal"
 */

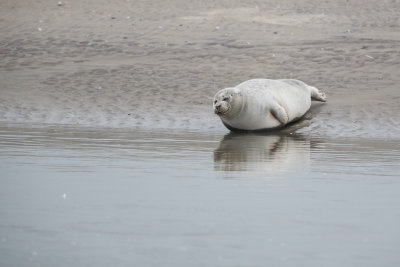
xmin=0 ymin=1 xmax=400 ymax=138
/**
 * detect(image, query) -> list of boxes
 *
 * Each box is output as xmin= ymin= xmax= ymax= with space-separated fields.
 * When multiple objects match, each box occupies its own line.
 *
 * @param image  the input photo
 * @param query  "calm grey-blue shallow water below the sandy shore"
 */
xmin=0 ymin=126 xmax=400 ymax=266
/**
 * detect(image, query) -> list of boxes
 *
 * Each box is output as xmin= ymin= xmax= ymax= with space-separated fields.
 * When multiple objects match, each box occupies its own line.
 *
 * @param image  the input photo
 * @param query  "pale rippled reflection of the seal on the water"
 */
xmin=214 ymin=133 xmax=311 ymax=174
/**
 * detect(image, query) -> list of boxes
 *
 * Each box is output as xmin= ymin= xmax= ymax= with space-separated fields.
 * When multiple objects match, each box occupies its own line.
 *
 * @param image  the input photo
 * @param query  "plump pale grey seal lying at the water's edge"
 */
xmin=214 ymin=79 xmax=326 ymax=130
